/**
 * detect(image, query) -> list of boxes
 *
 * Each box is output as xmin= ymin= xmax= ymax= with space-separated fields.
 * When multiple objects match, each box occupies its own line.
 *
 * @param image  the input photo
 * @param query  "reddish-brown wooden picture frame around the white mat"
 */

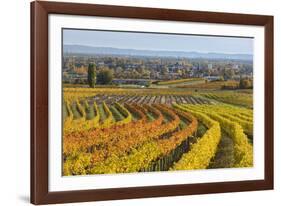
xmin=31 ymin=1 xmax=273 ymax=204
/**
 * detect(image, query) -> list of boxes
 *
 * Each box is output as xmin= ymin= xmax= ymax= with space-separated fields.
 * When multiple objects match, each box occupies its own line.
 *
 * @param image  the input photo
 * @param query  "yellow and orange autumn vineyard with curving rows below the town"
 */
xmin=62 ymin=88 xmax=253 ymax=176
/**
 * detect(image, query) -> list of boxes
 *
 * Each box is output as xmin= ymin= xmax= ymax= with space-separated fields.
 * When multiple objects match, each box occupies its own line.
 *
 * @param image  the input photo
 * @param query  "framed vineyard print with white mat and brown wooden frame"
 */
xmin=31 ymin=1 xmax=273 ymax=204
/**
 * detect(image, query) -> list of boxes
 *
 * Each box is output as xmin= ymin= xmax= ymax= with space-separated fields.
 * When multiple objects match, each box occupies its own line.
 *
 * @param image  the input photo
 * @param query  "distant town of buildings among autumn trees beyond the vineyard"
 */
xmin=62 ymin=56 xmax=253 ymax=85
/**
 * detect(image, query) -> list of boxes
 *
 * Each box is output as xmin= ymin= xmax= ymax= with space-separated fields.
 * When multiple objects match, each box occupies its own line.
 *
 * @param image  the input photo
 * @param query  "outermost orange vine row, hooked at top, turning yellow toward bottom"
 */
xmin=90 ymin=105 xmax=197 ymax=174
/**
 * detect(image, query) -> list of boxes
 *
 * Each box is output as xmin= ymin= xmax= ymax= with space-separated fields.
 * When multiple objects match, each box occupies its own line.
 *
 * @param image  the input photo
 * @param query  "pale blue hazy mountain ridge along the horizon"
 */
xmin=63 ymin=45 xmax=253 ymax=60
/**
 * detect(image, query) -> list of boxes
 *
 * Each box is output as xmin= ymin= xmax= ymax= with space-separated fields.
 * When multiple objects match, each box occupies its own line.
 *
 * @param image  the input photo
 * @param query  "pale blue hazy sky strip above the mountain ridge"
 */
xmin=63 ymin=29 xmax=253 ymax=54
